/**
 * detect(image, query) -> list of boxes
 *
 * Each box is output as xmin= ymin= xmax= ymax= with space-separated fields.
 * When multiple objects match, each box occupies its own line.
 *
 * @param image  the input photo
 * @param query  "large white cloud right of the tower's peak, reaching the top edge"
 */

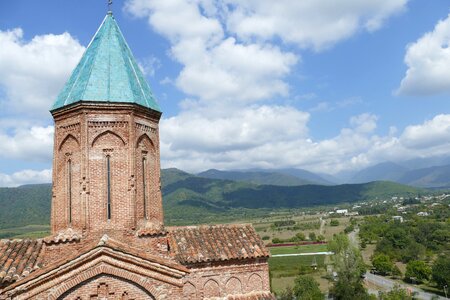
xmin=125 ymin=0 xmax=408 ymax=105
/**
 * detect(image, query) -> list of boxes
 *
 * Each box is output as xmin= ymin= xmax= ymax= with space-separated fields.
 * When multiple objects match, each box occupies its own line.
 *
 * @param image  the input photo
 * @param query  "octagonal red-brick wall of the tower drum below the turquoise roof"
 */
xmin=51 ymin=104 xmax=163 ymax=238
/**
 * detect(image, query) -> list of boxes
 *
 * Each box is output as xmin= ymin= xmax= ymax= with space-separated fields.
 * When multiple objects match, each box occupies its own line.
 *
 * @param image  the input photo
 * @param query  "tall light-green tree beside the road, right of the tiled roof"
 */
xmin=328 ymin=233 xmax=370 ymax=300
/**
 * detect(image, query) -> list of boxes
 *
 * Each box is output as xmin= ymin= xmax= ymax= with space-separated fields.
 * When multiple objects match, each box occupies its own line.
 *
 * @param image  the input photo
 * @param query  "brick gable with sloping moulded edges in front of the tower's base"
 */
xmin=0 ymin=239 xmax=189 ymax=299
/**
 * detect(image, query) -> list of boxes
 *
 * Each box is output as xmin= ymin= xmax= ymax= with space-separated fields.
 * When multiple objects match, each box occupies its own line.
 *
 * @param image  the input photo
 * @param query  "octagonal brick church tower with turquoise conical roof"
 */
xmin=51 ymin=13 xmax=163 ymax=236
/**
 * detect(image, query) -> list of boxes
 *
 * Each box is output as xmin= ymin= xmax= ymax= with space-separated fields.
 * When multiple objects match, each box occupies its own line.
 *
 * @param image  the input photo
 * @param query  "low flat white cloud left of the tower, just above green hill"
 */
xmin=0 ymin=169 xmax=52 ymax=187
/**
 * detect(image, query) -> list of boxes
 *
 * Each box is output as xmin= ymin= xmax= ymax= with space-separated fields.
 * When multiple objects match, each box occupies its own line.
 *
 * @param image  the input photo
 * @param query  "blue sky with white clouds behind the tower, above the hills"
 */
xmin=0 ymin=0 xmax=450 ymax=186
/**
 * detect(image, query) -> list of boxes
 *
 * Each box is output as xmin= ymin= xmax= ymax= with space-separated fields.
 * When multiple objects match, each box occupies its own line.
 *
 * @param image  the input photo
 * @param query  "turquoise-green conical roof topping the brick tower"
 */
xmin=51 ymin=13 xmax=161 ymax=112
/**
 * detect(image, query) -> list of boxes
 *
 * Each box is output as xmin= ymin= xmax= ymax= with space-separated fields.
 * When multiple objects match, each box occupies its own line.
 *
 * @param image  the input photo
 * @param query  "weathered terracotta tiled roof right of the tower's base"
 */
xmin=168 ymin=225 xmax=269 ymax=264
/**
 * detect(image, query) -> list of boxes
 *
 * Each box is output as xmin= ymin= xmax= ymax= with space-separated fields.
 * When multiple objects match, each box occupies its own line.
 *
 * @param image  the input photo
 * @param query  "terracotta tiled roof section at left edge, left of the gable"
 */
xmin=0 ymin=240 xmax=42 ymax=285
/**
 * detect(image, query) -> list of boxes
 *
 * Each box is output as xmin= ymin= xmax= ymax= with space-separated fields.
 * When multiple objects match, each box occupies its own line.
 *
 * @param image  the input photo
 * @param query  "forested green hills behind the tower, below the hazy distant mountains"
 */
xmin=0 ymin=169 xmax=421 ymax=229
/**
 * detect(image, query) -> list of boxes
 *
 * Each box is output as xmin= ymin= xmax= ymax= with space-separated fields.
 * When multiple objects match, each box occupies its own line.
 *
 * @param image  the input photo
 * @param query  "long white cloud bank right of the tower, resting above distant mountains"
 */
xmin=161 ymin=111 xmax=450 ymax=174
